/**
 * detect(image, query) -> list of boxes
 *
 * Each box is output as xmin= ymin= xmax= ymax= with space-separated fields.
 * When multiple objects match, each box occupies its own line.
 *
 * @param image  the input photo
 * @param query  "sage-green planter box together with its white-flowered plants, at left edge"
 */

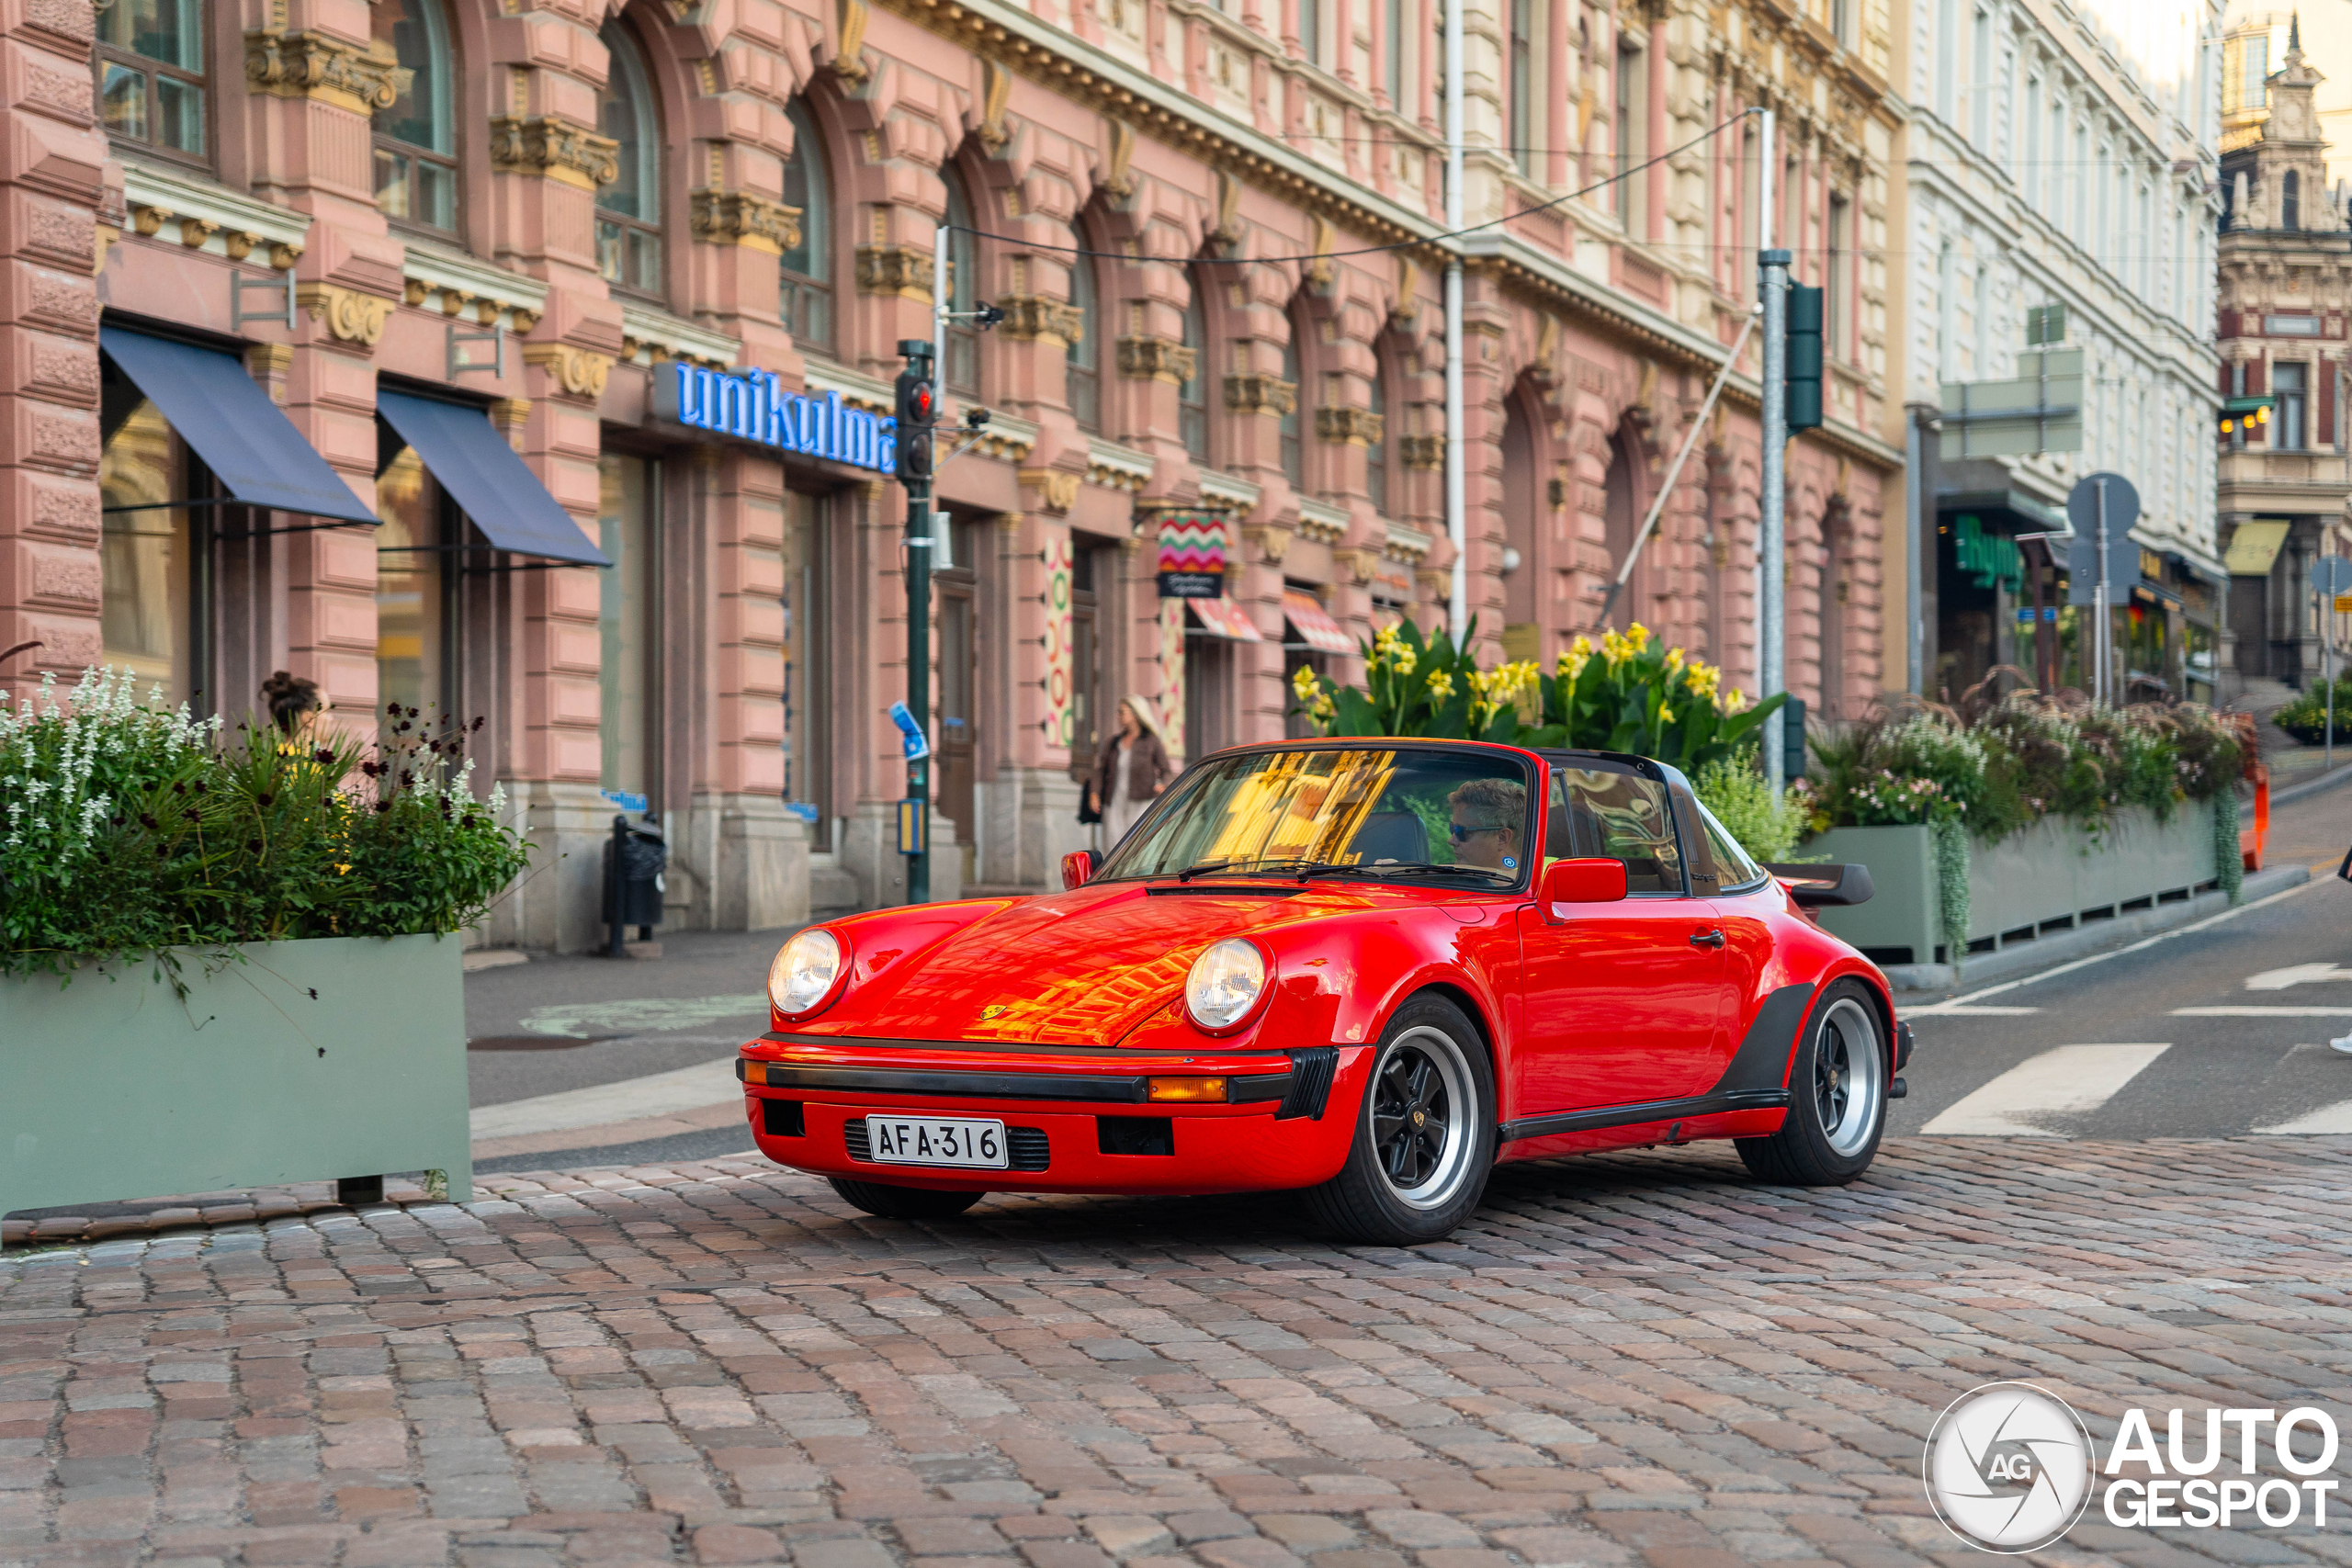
xmin=0 ymin=670 xmax=529 ymax=1213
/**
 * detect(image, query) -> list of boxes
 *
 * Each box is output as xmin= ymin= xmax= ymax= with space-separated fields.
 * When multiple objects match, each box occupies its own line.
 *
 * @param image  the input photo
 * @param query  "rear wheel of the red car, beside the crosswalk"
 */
xmin=1734 ymin=980 xmax=1894 ymax=1187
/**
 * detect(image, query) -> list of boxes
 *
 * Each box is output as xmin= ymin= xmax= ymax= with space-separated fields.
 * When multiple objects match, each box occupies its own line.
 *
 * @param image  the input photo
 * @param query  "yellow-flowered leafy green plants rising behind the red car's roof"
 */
xmin=1291 ymin=618 xmax=1782 ymax=771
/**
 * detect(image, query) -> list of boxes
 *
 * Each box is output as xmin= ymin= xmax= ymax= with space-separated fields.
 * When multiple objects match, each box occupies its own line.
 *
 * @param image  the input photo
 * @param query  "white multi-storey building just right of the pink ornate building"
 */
xmin=1889 ymin=0 xmax=2227 ymax=698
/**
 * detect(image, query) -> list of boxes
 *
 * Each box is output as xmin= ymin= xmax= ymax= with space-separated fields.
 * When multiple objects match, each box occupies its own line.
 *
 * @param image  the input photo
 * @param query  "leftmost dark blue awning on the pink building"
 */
xmin=99 ymin=327 xmax=377 ymax=525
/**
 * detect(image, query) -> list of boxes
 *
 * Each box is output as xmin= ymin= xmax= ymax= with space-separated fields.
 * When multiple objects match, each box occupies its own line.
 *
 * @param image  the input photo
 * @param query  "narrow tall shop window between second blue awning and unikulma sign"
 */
xmin=597 ymin=451 xmax=661 ymax=808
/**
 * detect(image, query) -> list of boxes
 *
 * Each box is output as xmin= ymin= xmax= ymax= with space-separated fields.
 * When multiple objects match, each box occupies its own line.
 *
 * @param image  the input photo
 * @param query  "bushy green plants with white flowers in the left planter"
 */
xmin=0 ymin=670 xmax=529 ymax=974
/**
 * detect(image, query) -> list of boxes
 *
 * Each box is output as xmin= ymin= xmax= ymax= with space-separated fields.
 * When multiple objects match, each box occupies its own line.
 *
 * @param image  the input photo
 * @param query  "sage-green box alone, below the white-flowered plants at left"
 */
xmin=0 ymin=936 xmax=473 ymax=1213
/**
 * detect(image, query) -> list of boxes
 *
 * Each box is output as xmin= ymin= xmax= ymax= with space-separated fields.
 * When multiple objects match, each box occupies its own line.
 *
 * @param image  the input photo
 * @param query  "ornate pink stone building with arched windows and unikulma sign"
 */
xmin=0 ymin=0 xmax=1900 ymax=950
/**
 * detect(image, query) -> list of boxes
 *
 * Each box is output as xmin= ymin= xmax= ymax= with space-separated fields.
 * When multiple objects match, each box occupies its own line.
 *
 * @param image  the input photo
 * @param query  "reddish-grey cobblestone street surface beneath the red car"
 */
xmin=0 ymin=1138 xmax=2352 ymax=1568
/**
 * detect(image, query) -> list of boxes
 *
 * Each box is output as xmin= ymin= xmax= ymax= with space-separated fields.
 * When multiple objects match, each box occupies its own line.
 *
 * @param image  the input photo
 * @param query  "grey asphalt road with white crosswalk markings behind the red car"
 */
xmin=466 ymin=785 xmax=2352 ymax=1173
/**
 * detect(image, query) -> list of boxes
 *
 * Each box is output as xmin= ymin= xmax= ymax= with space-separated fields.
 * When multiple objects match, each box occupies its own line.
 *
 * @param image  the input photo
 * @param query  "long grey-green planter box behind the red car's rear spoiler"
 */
xmin=1804 ymin=802 xmax=2218 ymax=964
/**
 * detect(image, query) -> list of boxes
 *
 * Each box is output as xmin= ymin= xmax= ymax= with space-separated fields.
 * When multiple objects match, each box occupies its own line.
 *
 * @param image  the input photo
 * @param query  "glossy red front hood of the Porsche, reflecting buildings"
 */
xmin=795 ymin=882 xmax=1428 ymax=1046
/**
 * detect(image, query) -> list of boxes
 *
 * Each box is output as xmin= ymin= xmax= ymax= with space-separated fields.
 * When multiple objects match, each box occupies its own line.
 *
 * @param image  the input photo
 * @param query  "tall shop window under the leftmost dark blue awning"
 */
xmin=99 ymin=392 xmax=202 ymax=705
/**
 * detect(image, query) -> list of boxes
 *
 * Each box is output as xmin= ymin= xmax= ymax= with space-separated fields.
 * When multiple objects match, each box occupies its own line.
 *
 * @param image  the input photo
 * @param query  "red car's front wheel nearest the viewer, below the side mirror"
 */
xmin=1306 ymin=997 xmax=1496 ymax=1246
